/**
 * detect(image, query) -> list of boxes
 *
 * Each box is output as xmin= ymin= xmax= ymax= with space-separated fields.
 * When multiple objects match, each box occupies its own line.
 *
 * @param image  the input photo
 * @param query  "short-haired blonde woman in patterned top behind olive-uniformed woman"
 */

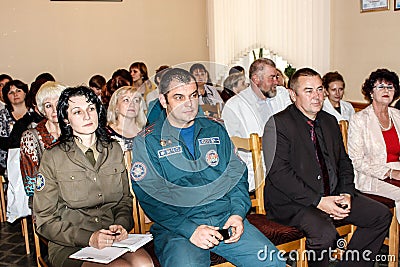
xmin=21 ymin=82 xmax=65 ymax=208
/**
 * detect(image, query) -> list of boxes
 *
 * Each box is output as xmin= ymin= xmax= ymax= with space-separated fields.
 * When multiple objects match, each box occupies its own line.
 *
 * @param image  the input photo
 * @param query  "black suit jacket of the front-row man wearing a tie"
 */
xmin=263 ymin=104 xmax=354 ymax=224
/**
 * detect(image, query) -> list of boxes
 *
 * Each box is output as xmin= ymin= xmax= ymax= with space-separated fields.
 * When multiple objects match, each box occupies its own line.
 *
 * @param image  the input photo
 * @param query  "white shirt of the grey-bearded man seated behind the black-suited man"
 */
xmin=222 ymin=86 xmax=292 ymax=191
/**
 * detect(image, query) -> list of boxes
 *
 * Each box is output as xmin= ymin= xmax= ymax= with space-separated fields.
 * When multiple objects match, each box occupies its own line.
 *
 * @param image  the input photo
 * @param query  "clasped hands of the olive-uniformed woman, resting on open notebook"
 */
xmin=89 ymin=225 xmax=128 ymax=249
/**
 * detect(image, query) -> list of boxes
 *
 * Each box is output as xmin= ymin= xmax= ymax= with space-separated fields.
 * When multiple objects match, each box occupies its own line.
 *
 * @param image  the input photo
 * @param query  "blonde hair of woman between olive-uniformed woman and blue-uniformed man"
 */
xmin=107 ymin=86 xmax=146 ymax=129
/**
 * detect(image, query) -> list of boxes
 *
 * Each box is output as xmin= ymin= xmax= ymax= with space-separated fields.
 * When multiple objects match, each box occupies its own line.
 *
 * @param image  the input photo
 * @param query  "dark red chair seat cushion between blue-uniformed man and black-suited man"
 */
xmin=247 ymin=214 xmax=304 ymax=246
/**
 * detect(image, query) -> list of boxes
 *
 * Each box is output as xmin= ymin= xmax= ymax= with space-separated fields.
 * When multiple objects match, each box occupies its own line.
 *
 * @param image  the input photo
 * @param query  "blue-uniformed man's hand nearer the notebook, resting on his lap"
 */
xmin=189 ymin=225 xmax=223 ymax=249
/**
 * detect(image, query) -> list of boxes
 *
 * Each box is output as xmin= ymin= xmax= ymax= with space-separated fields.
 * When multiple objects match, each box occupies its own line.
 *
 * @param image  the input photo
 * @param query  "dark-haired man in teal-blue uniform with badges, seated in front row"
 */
xmin=131 ymin=68 xmax=285 ymax=267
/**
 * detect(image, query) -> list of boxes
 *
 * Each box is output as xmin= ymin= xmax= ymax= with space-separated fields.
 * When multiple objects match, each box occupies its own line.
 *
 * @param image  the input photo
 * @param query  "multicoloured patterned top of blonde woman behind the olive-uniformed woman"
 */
xmin=20 ymin=119 xmax=57 ymax=196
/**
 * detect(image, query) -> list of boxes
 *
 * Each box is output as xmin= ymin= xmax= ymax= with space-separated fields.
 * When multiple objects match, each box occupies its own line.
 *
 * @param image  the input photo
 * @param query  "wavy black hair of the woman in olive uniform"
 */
xmin=57 ymin=86 xmax=111 ymax=151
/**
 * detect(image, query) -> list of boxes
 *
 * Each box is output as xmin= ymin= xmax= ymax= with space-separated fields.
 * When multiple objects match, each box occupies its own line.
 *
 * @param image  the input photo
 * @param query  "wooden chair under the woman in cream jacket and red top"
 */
xmin=339 ymin=121 xmax=400 ymax=267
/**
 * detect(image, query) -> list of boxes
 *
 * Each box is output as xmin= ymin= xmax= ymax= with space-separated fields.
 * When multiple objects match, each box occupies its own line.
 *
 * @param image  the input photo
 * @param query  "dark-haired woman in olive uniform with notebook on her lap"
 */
xmin=33 ymin=86 xmax=152 ymax=267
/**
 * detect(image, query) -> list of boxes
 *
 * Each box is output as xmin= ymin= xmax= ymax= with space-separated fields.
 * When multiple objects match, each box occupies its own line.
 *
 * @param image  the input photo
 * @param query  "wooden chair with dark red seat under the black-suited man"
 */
xmin=231 ymin=133 xmax=307 ymax=267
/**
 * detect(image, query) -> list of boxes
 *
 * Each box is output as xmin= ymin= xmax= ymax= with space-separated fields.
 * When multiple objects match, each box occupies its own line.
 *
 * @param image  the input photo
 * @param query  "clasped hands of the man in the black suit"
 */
xmin=317 ymin=194 xmax=351 ymax=220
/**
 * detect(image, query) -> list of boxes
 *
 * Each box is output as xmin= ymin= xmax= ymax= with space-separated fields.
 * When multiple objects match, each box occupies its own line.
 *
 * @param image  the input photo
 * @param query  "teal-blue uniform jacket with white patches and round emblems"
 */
xmin=130 ymin=116 xmax=251 ymax=239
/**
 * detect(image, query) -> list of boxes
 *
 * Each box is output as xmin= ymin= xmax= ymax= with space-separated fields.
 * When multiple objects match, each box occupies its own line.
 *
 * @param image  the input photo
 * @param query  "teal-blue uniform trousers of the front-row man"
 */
xmin=154 ymin=220 xmax=285 ymax=267
